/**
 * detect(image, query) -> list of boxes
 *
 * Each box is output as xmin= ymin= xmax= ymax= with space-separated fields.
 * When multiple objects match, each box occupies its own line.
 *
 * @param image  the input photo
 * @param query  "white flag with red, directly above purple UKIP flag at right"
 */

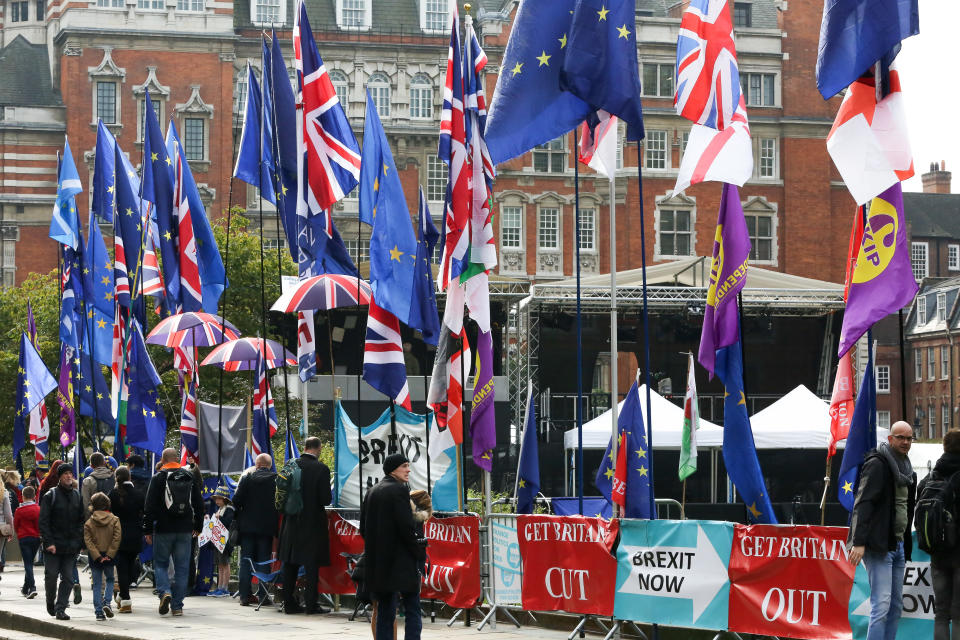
xmin=827 ymin=69 xmax=914 ymax=204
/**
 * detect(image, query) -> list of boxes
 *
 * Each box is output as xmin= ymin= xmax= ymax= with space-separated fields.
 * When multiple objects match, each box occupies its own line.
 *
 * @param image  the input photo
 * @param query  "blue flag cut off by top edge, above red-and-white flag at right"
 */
xmin=817 ymin=0 xmax=920 ymax=100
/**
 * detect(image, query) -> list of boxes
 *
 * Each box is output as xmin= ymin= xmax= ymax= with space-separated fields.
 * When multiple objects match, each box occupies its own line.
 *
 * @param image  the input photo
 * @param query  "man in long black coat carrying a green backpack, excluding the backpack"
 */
xmin=280 ymin=437 xmax=332 ymax=615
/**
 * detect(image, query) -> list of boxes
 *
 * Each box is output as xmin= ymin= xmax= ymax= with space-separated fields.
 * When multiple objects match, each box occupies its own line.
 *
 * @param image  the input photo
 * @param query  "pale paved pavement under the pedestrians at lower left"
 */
xmin=0 ymin=563 xmax=566 ymax=640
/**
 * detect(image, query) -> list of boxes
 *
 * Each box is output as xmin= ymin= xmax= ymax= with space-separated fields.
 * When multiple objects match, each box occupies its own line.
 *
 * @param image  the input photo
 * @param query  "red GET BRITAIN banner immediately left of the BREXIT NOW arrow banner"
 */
xmin=517 ymin=515 xmax=620 ymax=616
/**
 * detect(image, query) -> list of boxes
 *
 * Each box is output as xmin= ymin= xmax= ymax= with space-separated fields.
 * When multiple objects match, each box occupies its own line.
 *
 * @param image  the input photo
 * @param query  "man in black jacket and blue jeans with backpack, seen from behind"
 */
xmin=143 ymin=448 xmax=203 ymax=616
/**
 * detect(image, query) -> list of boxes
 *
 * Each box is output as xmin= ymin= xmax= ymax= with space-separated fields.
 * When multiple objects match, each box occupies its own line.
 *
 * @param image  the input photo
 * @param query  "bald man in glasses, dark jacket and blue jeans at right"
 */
xmin=847 ymin=421 xmax=917 ymax=640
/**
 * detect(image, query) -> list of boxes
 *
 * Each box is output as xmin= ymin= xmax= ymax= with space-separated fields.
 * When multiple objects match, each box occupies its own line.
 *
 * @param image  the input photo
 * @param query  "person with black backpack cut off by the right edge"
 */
xmin=916 ymin=429 xmax=960 ymax=640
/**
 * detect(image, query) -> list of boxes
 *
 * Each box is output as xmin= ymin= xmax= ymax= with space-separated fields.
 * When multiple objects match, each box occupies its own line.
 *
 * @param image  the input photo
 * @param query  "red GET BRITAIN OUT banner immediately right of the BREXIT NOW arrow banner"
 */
xmin=729 ymin=524 xmax=854 ymax=640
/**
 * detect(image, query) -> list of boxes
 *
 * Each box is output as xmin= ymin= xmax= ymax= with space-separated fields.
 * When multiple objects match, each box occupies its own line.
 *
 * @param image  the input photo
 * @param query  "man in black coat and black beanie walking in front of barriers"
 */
xmin=360 ymin=453 xmax=423 ymax=640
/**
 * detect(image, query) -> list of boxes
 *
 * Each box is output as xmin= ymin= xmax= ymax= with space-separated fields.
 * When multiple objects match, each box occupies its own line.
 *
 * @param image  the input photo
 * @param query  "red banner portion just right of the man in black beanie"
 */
xmin=420 ymin=516 xmax=482 ymax=609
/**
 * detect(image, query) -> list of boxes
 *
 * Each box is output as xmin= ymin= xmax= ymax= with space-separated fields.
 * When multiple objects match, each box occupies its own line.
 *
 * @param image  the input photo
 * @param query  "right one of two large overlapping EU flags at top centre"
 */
xmin=560 ymin=0 xmax=644 ymax=140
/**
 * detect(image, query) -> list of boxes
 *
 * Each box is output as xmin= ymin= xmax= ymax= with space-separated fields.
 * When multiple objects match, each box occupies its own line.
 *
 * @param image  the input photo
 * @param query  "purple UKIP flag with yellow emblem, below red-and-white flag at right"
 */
xmin=837 ymin=182 xmax=919 ymax=356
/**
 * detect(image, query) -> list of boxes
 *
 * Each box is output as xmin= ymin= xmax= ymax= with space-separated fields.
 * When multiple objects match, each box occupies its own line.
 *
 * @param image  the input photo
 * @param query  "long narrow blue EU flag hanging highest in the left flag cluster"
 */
xmin=142 ymin=92 xmax=181 ymax=312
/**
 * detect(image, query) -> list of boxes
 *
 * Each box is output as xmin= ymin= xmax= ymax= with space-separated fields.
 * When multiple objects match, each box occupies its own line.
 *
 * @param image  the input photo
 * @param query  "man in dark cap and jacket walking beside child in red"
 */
xmin=40 ymin=464 xmax=84 ymax=620
